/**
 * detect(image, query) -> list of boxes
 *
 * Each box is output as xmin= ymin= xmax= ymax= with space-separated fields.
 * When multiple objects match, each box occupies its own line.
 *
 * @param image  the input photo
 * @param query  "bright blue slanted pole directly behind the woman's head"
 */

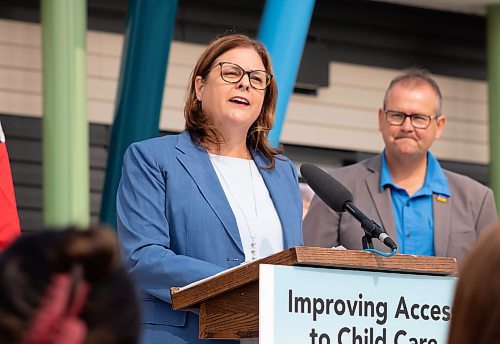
xmin=258 ymin=0 xmax=315 ymax=147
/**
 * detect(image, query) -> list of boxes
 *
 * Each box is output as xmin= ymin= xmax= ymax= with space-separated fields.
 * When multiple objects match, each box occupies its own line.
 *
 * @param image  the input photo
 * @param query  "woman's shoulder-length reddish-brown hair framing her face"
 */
xmin=184 ymin=34 xmax=281 ymax=169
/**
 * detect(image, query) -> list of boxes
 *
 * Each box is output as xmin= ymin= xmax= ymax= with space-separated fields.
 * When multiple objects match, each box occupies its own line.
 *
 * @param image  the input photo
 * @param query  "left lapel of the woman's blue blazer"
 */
xmin=176 ymin=132 xmax=243 ymax=253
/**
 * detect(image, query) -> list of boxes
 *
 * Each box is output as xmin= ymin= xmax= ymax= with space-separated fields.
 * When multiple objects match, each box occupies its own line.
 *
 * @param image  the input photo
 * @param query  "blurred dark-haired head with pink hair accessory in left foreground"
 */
xmin=0 ymin=227 xmax=140 ymax=344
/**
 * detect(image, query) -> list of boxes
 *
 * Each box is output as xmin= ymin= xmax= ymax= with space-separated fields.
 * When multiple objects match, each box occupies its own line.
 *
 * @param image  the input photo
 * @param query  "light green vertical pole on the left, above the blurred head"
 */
xmin=41 ymin=0 xmax=90 ymax=228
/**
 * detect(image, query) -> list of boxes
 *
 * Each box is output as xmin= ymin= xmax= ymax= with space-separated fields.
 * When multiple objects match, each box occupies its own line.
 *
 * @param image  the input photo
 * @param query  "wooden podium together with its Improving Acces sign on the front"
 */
xmin=170 ymin=246 xmax=457 ymax=344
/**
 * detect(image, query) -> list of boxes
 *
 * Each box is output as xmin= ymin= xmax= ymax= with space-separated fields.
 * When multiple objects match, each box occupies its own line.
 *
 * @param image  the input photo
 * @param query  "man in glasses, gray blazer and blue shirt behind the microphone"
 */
xmin=303 ymin=69 xmax=497 ymax=262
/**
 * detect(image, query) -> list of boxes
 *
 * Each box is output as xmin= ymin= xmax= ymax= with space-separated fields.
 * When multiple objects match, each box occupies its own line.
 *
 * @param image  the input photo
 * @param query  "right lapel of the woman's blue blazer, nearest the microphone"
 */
xmin=252 ymin=152 xmax=299 ymax=248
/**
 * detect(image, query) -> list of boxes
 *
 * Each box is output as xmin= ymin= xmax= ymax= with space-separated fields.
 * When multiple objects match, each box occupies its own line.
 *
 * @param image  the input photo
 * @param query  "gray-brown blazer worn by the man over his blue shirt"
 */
xmin=303 ymin=155 xmax=497 ymax=262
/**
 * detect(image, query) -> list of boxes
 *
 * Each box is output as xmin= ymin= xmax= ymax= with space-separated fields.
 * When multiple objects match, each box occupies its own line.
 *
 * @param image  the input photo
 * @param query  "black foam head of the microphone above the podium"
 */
xmin=300 ymin=163 xmax=352 ymax=212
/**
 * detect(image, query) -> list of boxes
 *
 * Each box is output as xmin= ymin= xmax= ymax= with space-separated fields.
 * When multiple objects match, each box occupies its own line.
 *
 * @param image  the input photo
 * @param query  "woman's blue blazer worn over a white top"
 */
xmin=117 ymin=132 xmax=303 ymax=343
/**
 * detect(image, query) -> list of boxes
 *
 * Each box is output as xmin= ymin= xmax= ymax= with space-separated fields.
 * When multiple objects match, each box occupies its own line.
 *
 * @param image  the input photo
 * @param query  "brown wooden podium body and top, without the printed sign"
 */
xmin=170 ymin=246 xmax=457 ymax=339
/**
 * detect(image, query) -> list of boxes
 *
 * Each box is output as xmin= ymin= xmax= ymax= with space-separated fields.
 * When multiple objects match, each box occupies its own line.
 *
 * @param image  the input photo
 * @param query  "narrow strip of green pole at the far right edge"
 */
xmin=486 ymin=5 xmax=500 ymax=213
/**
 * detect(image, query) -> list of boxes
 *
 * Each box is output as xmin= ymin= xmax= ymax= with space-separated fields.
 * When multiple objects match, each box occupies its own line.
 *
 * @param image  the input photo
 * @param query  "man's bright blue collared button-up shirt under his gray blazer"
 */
xmin=380 ymin=151 xmax=451 ymax=256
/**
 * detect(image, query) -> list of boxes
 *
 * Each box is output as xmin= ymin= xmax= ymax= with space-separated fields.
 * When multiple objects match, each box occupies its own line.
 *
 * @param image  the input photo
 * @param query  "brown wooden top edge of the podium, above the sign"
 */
xmin=170 ymin=246 xmax=457 ymax=310
